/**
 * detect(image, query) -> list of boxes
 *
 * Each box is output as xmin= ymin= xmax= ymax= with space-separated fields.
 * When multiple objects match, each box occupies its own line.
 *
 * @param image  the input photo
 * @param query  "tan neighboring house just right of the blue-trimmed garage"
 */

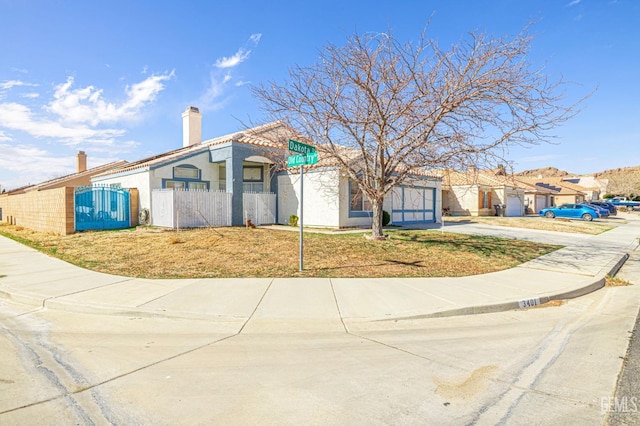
xmin=438 ymin=168 xmax=525 ymax=216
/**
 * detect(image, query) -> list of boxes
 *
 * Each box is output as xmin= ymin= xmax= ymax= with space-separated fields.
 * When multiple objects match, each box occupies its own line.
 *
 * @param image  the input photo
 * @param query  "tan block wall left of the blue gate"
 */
xmin=0 ymin=187 xmax=75 ymax=235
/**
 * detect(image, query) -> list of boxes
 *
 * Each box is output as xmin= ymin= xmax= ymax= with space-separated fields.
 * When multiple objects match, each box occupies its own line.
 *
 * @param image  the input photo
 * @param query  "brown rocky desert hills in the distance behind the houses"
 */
xmin=516 ymin=166 xmax=640 ymax=195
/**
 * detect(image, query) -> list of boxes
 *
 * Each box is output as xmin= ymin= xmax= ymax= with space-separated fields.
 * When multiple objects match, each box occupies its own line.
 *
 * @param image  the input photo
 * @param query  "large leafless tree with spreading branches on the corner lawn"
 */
xmin=252 ymin=27 xmax=575 ymax=237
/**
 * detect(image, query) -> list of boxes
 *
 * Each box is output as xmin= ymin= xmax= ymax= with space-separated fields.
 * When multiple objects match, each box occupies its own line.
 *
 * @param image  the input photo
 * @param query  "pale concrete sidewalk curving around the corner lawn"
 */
xmin=0 ymin=220 xmax=640 ymax=332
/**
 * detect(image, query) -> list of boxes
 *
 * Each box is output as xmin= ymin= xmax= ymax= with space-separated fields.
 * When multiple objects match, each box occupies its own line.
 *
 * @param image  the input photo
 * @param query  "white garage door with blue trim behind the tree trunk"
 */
xmin=391 ymin=186 xmax=436 ymax=225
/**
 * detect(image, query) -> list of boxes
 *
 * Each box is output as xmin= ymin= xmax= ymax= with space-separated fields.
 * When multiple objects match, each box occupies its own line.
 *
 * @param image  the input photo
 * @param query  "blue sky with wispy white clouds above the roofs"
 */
xmin=0 ymin=0 xmax=640 ymax=188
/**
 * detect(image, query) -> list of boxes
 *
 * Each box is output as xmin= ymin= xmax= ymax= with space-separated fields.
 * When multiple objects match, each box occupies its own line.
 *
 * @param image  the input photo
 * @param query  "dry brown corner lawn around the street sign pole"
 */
xmin=0 ymin=225 xmax=559 ymax=278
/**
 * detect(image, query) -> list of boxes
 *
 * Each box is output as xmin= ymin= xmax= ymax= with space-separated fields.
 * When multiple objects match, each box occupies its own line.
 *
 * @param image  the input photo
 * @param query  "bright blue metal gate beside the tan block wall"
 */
xmin=74 ymin=186 xmax=131 ymax=231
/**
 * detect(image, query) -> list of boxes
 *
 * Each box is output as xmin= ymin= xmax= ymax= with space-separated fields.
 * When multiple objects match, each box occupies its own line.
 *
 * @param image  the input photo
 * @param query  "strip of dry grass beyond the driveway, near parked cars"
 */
xmin=444 ymin=216 xmax=624 ymax=235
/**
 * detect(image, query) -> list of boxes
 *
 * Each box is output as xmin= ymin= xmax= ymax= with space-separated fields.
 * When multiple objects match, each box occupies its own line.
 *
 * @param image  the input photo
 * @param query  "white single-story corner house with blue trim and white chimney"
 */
xmin=92 ymin=107 xmax=441 ymax=228
